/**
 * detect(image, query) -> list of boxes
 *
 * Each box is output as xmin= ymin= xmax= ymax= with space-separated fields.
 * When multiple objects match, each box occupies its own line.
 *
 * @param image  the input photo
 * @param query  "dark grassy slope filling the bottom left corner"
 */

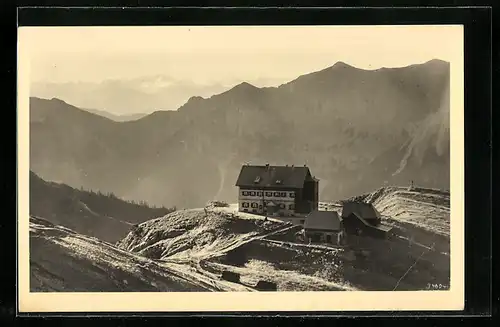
xmin=30 ymin=217 xmax=213 ymax=292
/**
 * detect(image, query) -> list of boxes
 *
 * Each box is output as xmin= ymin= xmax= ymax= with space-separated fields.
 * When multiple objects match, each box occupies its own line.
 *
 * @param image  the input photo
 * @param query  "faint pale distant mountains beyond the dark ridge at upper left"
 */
xmin=30 ymin=75 xmax=286 ymax=115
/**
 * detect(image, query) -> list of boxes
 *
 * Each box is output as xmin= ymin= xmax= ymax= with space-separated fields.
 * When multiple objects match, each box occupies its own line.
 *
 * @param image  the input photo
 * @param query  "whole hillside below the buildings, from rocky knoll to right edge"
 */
xmin=118 ymin=197 xmax=450 ymax=291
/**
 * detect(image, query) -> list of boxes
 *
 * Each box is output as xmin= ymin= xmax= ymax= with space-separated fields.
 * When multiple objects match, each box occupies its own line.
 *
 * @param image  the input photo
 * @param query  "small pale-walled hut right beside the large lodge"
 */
xmin=304 ymin=210 xmax=343 ymax=244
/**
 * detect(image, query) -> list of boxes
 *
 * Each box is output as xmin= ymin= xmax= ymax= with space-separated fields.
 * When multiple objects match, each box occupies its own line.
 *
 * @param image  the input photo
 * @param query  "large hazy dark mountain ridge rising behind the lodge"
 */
xmin=30 ymin=60 xmax=450 ymax=207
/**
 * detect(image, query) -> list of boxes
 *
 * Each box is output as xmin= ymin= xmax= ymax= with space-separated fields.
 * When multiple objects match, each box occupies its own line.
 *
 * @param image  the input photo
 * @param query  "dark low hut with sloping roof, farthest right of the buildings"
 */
xmin=342 ymin=201 xmax=392 ymax=239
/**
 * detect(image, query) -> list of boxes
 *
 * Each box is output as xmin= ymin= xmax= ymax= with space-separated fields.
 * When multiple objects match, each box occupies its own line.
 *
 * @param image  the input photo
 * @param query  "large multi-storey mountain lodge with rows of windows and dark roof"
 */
xmin=236 ymin=164 xmax=319 ymax=220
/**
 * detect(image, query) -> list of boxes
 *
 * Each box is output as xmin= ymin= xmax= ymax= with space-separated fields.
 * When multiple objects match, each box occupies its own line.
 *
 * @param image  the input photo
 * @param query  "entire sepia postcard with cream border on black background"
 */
xmin=18 ymin=25 xmax=464 ymax=312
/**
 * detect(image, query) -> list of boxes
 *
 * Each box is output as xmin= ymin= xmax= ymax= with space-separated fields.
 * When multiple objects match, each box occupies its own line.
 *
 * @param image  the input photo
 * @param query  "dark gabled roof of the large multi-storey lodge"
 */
xmin=236 ymin=165 xmax=312 ymax=188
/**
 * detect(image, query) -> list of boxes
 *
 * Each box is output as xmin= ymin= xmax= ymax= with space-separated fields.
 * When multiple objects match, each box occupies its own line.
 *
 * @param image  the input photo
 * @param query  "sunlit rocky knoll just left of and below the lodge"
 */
xmin=117 ymin=209 xmax=291 ymax=259
